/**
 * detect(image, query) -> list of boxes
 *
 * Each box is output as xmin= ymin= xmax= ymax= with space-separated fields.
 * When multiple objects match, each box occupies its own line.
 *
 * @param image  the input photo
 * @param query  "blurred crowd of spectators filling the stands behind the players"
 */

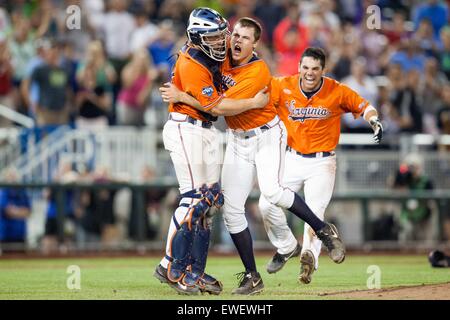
xmin=0 ymin=0 xmax=450 ymax=135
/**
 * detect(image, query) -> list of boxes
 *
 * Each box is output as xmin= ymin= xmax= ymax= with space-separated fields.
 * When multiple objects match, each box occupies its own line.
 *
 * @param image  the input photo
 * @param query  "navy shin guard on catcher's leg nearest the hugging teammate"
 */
xmin=191 ymin=218 xmax=211 ymax=276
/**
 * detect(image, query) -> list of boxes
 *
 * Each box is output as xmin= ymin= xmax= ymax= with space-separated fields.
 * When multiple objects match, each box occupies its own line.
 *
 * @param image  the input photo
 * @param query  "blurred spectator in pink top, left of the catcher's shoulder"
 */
xmin=117 ymin=48 xmax=157 ymax=126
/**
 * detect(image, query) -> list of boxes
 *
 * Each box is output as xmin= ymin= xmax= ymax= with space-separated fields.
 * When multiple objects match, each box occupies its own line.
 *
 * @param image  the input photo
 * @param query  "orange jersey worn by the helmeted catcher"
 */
xmin=169 ymin=46 xmax=223 ymax=121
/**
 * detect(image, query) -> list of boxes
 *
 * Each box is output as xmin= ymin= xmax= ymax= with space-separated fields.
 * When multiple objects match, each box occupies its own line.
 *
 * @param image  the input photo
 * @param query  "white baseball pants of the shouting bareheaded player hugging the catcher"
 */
xmin=222 ymin=116 xmax=294 ymax=234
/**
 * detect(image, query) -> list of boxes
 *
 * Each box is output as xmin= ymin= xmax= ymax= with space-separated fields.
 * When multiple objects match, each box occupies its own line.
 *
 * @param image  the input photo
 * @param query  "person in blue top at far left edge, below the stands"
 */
xmin=0 ymin=170 xmax=31 ymax=244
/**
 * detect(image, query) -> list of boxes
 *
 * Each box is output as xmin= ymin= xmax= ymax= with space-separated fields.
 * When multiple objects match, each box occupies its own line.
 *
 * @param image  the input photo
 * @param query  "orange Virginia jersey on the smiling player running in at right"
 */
xmin=271 ymin=75 xmax=369 ymax=154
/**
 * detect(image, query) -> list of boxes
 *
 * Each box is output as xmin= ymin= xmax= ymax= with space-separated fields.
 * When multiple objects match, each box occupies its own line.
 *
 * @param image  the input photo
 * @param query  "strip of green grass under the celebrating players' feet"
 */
xmin=0 ymin=255 xmax=449 ymax=300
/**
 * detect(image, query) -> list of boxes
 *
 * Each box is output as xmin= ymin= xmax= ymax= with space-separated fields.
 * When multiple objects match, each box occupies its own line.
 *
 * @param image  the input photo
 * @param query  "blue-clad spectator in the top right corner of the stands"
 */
xmin=413 ymin=0 xmax=449 ymax=38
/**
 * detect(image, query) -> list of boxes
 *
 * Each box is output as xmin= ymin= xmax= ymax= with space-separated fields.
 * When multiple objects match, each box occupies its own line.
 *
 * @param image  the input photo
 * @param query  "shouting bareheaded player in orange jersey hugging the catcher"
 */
xmin=163 ymin=18 xmax=345 ymax=295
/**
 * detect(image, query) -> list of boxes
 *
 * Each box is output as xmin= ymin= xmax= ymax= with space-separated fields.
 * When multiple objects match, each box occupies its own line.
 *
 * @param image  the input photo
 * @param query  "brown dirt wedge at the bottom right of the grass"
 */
xmin=320 ymin=282 xmax=450 ymax=300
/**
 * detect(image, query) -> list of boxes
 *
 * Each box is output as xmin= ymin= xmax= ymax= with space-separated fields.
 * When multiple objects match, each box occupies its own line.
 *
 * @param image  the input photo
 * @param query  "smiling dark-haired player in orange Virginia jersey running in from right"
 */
xmin=259 ymin=48 xmax=383 ymax=284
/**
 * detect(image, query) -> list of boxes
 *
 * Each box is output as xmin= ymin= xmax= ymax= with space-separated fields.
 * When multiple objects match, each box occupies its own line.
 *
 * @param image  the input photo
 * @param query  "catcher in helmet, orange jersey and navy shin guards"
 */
xmin=154 ymin=8 xmax=268 ymax=294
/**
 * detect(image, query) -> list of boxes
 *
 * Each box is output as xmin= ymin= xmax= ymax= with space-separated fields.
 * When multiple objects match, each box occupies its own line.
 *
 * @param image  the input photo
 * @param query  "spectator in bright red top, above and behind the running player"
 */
xmin=273 ymin=1 xmax=309 ymax=76
